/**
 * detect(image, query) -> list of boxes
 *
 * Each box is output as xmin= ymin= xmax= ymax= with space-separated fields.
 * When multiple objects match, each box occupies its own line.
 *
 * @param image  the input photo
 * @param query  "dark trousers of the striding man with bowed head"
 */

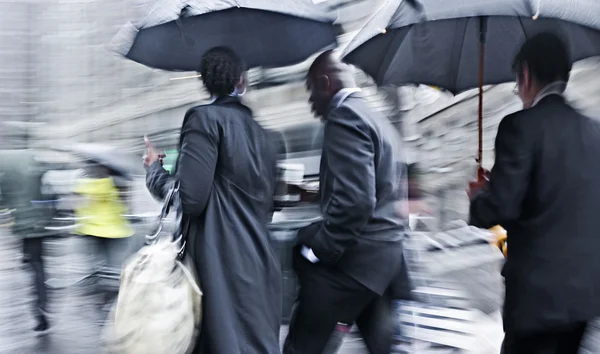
xmin=283 ymin=248 xmax=393 ymax=354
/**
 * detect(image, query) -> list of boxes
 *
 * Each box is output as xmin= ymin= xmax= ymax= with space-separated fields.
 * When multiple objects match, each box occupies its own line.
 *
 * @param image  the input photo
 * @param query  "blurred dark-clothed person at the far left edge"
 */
xmin=0 ymin=150 xmax=55 ymax=332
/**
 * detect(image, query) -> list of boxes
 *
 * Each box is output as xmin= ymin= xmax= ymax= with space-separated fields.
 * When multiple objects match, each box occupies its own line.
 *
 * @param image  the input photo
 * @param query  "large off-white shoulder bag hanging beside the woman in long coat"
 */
xmin=105 ymin=182 xmax=202 ymax=354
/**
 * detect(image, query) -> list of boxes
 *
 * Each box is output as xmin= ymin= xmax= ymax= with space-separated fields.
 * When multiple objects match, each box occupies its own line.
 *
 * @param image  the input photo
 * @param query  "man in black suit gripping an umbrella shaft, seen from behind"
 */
xmin=470 ymin=33 xmax=600 ymax=354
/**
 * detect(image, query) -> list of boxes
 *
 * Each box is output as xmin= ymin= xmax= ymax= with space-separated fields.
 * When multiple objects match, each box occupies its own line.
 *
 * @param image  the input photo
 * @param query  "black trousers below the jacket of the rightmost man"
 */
xmin=502 ymin=323 xmax=586 ymax=354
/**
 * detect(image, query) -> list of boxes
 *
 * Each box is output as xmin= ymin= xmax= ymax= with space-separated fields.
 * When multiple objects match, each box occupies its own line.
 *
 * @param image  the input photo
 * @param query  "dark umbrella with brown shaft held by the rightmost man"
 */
xmin=343 ymin=0 xmax=600 ymax=169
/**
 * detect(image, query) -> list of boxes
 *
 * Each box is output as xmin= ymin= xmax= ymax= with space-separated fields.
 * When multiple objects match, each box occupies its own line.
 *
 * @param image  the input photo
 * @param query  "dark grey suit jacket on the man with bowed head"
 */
xmin=307 ymin=93 xmax=408 ymax=294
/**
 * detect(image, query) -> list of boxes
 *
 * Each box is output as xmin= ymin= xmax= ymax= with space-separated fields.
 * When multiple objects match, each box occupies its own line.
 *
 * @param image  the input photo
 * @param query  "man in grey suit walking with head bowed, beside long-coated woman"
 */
xmin=284 ymin=52 xmax=408 ymax=354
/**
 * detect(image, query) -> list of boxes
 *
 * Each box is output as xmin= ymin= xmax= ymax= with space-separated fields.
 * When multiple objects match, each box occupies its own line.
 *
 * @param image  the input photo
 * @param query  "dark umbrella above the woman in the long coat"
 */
xmin=111 ymin=0 xmax=337 ymax=71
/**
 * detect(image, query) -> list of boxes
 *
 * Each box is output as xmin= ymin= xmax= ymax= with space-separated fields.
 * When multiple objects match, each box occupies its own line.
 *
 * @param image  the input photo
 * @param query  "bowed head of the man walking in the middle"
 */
xmin=306 ymin=50 xmax=355 ymax=117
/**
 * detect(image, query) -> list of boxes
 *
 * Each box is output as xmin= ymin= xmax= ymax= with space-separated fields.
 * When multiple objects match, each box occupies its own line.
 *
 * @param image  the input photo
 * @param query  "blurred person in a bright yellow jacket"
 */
xmin=74 ymin=163 xmax=134 ymax=316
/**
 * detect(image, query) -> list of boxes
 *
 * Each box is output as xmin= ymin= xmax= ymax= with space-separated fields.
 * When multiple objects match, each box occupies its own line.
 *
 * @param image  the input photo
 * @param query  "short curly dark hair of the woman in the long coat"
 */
xmin=200 ymin=47 xmax=246 ymax=97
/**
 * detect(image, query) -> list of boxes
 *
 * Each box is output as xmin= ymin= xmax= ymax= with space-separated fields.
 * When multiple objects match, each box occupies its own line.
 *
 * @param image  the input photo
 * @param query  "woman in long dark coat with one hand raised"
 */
xmin=145 ymin=47 xmax=282 ymax=354
